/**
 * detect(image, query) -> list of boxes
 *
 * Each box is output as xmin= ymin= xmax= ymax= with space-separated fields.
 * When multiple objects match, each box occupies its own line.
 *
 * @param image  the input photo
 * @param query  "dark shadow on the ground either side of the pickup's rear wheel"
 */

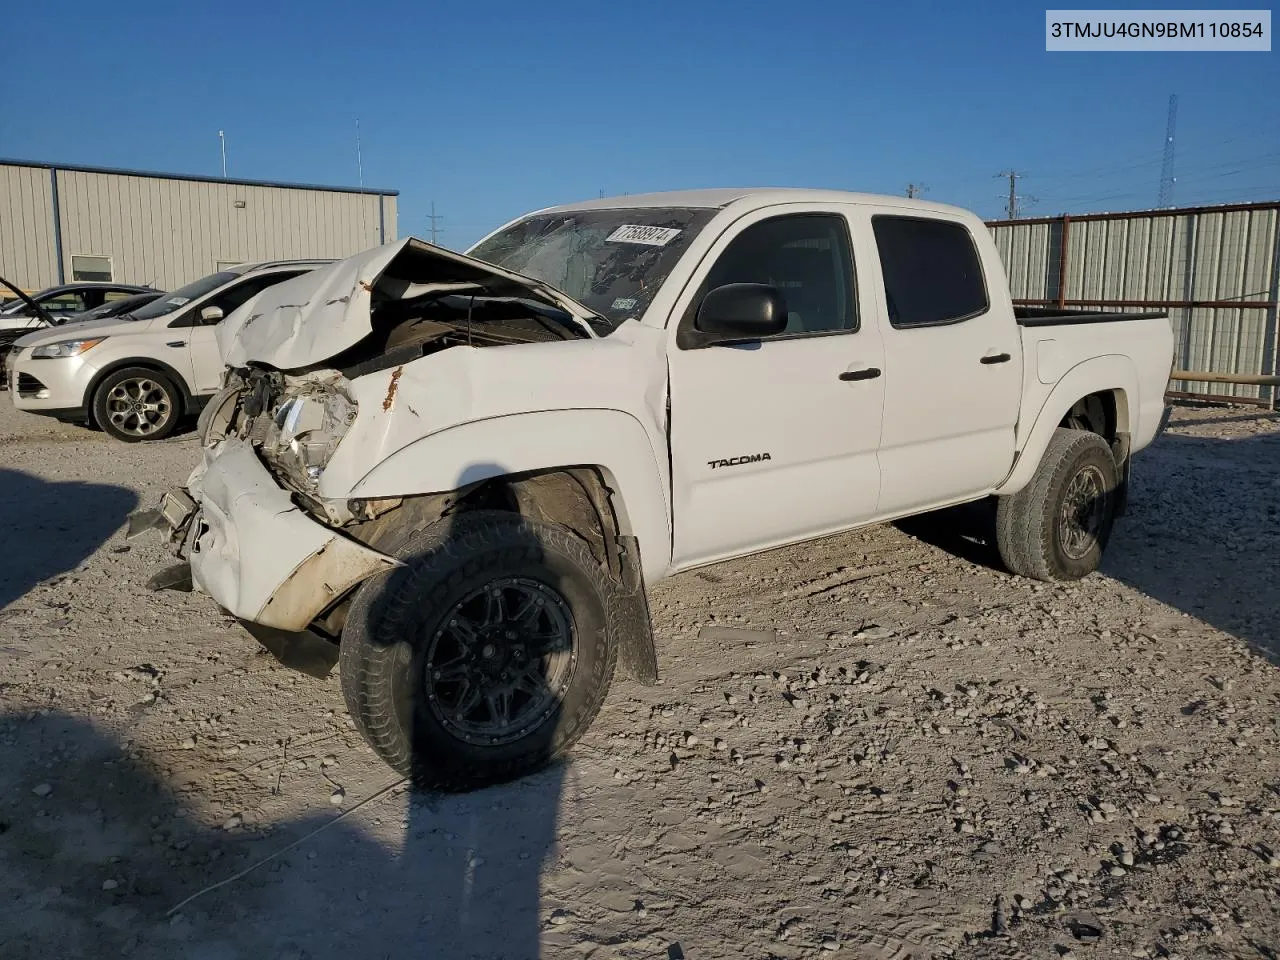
xmin=897 ymin=430 xmax=1280 ymax=664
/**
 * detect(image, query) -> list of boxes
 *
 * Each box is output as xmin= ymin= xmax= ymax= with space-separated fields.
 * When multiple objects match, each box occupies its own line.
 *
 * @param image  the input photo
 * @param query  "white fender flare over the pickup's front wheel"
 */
xmin=346 ymin=410 xmax=671 ymax=584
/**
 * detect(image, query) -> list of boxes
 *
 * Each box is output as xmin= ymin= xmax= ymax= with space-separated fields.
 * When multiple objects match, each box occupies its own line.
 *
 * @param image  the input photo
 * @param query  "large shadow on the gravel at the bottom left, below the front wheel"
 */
xmin=0 ymin=712 xmax=562 ymax=960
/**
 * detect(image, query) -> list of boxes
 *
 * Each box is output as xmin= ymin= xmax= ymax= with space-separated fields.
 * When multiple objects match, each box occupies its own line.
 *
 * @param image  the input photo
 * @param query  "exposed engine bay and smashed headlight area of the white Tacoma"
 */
xmin=201 ymin=291 xmax=588 ymax=526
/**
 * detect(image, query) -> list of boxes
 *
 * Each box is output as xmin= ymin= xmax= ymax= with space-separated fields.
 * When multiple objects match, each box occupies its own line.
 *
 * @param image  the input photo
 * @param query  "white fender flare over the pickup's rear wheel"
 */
xmin=995 ymin=353 xmax=1140 ymax=497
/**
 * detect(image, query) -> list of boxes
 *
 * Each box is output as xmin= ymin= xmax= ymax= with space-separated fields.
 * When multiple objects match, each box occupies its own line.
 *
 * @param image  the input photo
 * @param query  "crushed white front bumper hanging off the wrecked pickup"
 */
xmin=148 ymin=438 xmax=398 ymax=631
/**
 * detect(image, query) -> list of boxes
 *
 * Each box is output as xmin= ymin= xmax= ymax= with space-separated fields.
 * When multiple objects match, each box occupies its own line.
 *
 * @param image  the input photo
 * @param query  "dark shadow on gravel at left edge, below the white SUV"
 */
xmin=0 ymin=467 xmax=138 ymax=609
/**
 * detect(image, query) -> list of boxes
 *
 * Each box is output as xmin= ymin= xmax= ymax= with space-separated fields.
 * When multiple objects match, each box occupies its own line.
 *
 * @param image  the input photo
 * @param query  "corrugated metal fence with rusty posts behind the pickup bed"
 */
xmin=988 ymin=201 xmax=1280 ymax=407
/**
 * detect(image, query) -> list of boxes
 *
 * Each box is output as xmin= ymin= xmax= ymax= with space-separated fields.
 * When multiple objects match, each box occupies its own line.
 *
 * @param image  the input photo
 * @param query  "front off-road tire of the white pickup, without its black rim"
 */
xmin=339 ymin=511 xmax=620 ymax=790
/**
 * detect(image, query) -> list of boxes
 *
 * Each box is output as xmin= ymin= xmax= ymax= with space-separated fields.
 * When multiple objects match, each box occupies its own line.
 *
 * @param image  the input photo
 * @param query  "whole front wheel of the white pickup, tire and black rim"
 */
xmin=339 ymin=511 xmax=618 ymax=790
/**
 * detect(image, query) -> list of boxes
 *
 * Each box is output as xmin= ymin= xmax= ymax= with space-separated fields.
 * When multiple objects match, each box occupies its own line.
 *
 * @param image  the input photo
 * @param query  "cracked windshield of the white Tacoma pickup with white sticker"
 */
xmin=468 ymin=207 xmax=716 ymax=326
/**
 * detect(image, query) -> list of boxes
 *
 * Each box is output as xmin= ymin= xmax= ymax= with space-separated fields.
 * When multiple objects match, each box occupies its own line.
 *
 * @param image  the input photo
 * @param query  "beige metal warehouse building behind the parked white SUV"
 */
xmin=0 ymin=160 xmax=398 ymax=291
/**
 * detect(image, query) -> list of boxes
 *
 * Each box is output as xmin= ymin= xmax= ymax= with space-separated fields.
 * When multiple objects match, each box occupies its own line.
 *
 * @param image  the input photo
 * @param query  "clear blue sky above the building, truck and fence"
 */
xmin=0 ymin=0 xmax=1280 ymax=247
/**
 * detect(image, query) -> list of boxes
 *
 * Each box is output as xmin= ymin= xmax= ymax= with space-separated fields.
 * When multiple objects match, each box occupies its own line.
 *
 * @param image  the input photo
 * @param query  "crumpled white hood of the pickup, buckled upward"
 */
xmin=218 ymin=237 xmax=593 ymax=370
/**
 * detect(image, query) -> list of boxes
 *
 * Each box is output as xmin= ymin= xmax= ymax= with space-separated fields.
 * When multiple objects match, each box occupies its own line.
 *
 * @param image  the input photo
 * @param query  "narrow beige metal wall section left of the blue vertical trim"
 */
xmin=0 ymin=166 xmax=58 ymax=289
